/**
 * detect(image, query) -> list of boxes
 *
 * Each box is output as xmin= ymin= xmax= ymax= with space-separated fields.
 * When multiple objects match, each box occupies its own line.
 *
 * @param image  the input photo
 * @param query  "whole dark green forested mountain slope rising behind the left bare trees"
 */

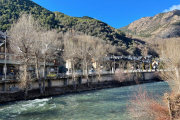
xmin=0 ymin=0 xmax=131 ymax=48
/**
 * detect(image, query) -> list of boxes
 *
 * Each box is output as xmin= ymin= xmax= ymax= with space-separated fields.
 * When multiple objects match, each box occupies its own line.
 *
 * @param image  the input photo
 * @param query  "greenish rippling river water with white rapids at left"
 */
xmin=0 ymin=82 xmax=170 ymax=120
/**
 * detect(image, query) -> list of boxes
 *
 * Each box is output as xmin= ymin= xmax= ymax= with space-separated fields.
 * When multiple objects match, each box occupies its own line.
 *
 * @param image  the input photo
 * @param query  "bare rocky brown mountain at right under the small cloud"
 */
xmin=119 ymin=10 xmax=180 ymax=39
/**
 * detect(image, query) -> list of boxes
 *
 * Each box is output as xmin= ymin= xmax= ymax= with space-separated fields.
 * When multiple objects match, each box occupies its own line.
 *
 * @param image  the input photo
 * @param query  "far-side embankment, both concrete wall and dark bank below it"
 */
xmin=0 ymin=70 xmax=163 ymax=103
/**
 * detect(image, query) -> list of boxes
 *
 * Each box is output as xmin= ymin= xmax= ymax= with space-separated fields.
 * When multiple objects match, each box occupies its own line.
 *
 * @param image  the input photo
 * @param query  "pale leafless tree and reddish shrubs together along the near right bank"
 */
xmin=130 ymin=38 xmax=180 ymax=120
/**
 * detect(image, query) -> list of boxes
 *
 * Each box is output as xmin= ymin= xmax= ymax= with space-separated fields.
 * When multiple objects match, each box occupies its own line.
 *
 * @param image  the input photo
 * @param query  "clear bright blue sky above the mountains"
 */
xmin=32 ymin=0 xmax=180 ymax=28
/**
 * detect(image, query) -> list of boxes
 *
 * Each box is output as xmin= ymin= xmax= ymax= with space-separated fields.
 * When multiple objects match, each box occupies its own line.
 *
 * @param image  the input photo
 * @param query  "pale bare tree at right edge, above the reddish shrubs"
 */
xmin=161 ymin=38 xmax=180 ymax=93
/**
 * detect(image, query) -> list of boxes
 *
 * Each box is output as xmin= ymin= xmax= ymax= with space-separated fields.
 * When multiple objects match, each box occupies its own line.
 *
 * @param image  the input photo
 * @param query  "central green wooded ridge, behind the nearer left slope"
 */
xmin=54 ymin=12 xmax=128 ymax=44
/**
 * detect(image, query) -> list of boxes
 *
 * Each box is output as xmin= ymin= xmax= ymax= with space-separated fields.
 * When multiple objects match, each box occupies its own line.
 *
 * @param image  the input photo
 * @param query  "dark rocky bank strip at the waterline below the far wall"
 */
xmin=0 ymin=80 xmax=160 ymax=103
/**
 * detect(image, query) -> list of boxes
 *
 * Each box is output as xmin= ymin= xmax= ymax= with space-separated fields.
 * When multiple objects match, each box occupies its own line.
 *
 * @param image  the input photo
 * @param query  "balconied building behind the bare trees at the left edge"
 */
xmin=0 ymin=31 xmax=64 ymax=79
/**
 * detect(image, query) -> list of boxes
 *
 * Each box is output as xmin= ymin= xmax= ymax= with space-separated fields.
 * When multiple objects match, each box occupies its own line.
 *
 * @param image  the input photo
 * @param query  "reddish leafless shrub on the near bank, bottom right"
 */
xmin=128 ymin=87 xmax=170 ymax=120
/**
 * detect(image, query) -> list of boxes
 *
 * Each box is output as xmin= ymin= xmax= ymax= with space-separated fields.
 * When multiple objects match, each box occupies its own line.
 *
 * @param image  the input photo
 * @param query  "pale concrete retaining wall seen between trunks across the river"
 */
xmin=0 ymin=72 xmax=156 ymax=92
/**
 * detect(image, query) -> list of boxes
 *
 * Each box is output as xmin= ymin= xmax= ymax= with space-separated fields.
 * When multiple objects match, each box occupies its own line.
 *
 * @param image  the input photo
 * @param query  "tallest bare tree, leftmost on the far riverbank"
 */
xmin=8 ymin=14 xmax=39 ymax=96
